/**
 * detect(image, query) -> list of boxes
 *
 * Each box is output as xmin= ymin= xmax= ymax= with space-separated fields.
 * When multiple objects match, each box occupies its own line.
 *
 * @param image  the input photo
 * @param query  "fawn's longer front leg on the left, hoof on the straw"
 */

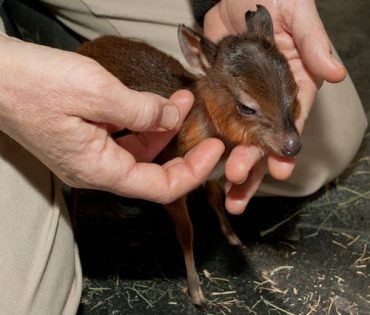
xmin=164 ymin=196 xmax=207 ymax=305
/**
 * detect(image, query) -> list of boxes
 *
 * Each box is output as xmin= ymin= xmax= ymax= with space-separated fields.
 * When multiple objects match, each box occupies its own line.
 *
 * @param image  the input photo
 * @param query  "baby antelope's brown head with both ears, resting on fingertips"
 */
xmin=178 ymin=5 xmax=301 ymax=157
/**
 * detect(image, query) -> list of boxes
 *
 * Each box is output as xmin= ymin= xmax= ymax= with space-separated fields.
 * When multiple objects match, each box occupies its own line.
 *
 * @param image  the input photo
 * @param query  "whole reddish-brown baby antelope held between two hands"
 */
xmin=78 ymin=6 xmax=300 ymax=304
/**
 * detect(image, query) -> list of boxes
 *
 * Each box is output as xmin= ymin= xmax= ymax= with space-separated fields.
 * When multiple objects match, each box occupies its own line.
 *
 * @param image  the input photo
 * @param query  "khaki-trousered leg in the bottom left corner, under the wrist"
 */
xmin=0 ymin=132 xmax=82 ymax=315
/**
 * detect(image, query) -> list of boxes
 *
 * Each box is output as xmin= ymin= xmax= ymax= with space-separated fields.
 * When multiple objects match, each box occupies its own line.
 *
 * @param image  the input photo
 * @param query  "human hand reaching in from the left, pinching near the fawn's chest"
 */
xmin=0 ymin=36 xmax=224 ymax=203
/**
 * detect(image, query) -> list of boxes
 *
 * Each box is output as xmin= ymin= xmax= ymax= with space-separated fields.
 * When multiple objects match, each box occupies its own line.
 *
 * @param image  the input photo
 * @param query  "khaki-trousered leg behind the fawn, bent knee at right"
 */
xmin=38 ymin=0 xmax=367 ymax=196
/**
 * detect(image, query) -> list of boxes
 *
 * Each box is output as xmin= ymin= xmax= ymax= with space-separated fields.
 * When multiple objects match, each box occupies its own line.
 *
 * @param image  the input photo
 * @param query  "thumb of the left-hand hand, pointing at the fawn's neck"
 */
xmin=79 ymin=78 xmax=188 ymax=131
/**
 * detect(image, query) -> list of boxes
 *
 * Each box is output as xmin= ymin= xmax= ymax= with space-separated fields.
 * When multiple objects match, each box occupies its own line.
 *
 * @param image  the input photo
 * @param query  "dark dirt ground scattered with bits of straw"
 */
xmin=76 ymin=0 xmax=370 ymax=315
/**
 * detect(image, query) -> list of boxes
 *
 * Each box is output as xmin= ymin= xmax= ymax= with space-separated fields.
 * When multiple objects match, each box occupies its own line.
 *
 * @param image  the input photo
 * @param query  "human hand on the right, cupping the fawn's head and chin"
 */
xmin=204 ymin=0 xmax=346 ymax=214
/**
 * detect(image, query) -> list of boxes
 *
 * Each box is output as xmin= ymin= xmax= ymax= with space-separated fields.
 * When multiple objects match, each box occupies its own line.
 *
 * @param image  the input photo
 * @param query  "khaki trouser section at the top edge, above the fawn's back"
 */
xmin=42 ymin=0 xmax=200 ymax=63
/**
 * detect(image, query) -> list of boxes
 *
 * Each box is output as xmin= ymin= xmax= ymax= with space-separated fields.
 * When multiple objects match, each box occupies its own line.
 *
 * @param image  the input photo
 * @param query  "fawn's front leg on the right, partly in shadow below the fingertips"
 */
xmin=205 ymin=180 xmax=244 ymax=246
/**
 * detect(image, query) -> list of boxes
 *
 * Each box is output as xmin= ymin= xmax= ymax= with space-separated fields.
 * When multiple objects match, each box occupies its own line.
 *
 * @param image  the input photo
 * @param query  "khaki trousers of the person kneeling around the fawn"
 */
xmin=0 ymin=0 xmax=367 ymax=315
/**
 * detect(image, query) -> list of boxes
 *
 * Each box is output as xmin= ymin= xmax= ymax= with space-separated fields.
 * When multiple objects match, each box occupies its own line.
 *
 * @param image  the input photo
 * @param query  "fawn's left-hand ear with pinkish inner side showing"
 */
xmin=177 ymin=25 xmax=218 ymax=75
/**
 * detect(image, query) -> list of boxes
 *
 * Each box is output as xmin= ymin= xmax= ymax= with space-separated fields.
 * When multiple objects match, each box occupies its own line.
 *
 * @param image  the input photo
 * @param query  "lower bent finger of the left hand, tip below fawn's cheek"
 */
xmin=101 ymin=139 xmax=225 ymax=204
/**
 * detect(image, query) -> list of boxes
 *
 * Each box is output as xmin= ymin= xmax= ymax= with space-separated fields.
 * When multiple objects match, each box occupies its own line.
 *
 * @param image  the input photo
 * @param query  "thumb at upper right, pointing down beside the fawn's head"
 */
xmin=292 ymin=0 xmax=346 ymax=83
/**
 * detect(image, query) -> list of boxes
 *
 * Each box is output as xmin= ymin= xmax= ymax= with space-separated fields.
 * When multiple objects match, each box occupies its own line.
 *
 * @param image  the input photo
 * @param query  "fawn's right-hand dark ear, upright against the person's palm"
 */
xmin=245 ymin=5 xmax=274 ymax=42
